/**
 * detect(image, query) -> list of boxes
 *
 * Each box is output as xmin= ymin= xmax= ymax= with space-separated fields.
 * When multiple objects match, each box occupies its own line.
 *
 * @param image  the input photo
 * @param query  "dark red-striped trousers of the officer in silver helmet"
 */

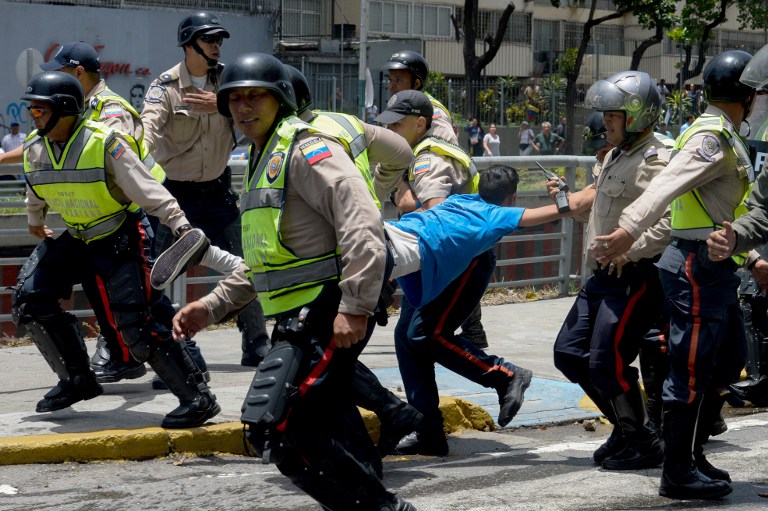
xmin=554 ymin=259 xmax=664 ymax=400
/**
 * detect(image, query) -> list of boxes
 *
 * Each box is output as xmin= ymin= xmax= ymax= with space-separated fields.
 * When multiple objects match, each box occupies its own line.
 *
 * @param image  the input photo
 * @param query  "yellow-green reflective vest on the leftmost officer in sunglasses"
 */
xmin=24 ymin=120 xmax=139 ymax=243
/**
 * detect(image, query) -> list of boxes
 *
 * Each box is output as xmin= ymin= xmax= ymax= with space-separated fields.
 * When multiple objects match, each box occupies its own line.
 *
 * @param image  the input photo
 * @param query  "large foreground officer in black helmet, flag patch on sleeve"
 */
xmin=174 ymin=53 xmax=413 ymax=510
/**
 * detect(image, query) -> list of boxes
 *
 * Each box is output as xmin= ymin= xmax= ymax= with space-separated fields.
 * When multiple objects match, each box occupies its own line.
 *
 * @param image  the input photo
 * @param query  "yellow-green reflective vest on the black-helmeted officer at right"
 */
xmin=671 ymin=114 xmax=754 ymax=264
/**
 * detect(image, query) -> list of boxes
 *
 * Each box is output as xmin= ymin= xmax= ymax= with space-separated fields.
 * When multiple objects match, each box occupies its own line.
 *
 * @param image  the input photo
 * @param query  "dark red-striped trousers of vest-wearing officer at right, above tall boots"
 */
xmin=658 ymin=238 xmax=747 ymax=403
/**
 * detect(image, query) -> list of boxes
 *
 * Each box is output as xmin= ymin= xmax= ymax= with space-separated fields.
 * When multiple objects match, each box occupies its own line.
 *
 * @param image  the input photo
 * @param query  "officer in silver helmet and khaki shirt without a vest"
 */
xmin=554 ymin=71 xmax=669 ymax=470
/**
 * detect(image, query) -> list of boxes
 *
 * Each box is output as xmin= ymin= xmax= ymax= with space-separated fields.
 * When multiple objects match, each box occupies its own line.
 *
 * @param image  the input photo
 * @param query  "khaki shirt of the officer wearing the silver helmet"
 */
xmin=584 ymin=133 xmax=670 ymax=267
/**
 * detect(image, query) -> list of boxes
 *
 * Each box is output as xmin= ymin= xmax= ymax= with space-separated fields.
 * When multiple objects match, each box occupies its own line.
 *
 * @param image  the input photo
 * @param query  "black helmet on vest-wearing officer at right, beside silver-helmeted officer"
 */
xmin=704 ymin=50 xmax=755 ymax=103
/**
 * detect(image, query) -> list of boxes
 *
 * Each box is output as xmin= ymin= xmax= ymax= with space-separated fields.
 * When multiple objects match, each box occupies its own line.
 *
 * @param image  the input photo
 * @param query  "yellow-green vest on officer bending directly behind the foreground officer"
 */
xmin=310 ymin=112 xmax=381 ymax=210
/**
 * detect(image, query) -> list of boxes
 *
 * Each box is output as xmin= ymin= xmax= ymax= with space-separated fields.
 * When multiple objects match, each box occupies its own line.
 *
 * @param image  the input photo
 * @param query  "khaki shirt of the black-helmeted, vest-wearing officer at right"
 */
xmin=619 ymin=105 xmax=747 ymax=245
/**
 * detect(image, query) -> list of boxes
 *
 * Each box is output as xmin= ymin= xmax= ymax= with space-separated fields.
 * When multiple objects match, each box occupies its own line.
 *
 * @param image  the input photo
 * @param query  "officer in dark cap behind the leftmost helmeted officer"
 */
xmin=40 ymin=41 xmax=184 ymax=383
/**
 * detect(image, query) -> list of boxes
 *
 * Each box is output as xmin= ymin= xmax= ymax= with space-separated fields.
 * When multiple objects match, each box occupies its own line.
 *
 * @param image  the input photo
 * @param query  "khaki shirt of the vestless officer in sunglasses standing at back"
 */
xmin=141 ymin=61 xmax=234 ymax=182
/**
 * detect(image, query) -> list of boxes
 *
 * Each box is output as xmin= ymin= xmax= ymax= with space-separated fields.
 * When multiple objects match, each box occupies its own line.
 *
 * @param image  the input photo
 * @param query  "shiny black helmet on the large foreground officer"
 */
xmin=216 ymin=53 xmax=296 ymax=117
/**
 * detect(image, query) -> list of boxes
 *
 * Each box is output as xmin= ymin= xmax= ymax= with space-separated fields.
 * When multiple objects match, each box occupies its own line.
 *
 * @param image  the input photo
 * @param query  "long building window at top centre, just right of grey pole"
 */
xmin=368 ymin=2 xmax=453 ymax=38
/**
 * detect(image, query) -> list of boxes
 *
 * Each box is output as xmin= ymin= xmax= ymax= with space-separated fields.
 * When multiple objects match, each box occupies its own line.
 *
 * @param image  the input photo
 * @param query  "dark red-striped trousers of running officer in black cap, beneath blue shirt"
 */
xmin=395 ymin=250 xmax=516 ymax=432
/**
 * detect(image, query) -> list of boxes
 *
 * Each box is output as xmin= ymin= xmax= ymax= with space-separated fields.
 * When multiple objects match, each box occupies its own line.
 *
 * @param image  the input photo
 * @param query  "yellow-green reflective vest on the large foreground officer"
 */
xmin=240 ymin=117 xmax=341 ymax=317
